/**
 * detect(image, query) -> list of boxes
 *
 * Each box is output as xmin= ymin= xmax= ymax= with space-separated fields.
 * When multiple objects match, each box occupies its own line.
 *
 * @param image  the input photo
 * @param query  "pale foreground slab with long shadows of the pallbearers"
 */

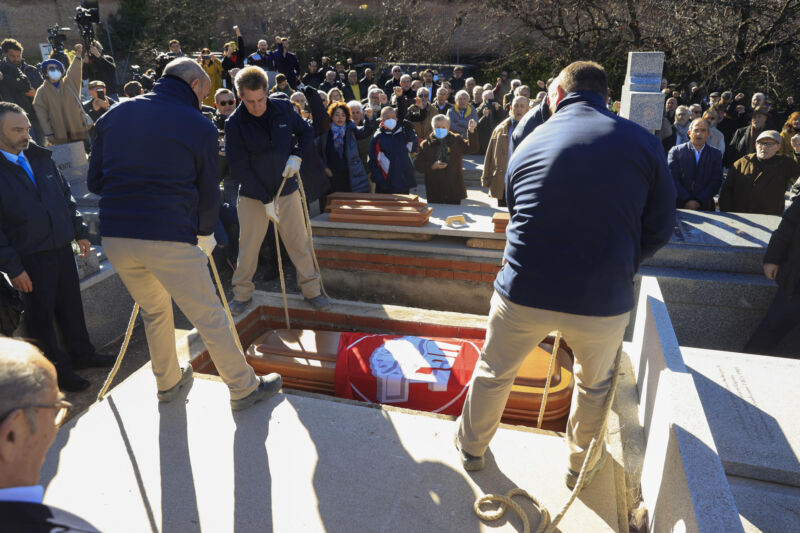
xmin=42 ymin=371 xmax=620 ymax=533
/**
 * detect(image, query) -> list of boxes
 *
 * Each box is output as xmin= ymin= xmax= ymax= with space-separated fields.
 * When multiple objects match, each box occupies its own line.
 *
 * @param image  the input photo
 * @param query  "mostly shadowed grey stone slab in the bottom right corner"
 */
xmin=728 ymin=476 xmax=800 ymax=533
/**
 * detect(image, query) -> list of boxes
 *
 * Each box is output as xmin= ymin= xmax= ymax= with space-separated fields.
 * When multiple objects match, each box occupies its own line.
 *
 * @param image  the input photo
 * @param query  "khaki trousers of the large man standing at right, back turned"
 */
xmin=458 ymin=291 xmax=630 ymax=472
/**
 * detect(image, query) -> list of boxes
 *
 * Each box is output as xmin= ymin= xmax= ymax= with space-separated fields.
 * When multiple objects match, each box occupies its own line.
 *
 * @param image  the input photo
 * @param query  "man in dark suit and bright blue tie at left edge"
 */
xmin=0 ymin=102 xmax=109 ymax=392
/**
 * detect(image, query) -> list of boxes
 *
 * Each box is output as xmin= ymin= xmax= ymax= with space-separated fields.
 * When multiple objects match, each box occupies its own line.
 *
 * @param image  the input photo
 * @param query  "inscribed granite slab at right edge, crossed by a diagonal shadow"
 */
xmin=682 ymin=348 xmax=800 ymax=487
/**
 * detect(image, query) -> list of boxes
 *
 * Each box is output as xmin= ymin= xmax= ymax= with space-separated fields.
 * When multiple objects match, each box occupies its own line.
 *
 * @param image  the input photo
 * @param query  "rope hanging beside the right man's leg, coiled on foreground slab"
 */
xmin=473 ymin=342 xmax=622 ymax=533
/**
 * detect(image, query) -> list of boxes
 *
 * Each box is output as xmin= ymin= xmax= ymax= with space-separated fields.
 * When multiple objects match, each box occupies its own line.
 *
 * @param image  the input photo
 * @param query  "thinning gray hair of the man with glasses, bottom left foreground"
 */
xmin=0 ymin=337 xmax=53 ymax=431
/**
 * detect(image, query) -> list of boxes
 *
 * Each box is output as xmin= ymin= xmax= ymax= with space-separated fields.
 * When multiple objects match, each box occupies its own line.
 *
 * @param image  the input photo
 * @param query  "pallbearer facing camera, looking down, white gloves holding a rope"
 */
xmin=225 ymin=67 xmax=329 ymax=314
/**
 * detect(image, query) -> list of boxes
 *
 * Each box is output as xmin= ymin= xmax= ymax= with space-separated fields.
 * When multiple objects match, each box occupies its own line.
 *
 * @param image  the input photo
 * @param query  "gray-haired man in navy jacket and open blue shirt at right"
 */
xmin=667 ymin=118 xmax=722 ymax=211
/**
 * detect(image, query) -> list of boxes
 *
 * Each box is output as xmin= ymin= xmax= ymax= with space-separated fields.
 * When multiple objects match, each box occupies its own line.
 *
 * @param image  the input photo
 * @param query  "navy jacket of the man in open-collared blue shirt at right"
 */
xmin=667 ymin=142 xmax=722 ymax=211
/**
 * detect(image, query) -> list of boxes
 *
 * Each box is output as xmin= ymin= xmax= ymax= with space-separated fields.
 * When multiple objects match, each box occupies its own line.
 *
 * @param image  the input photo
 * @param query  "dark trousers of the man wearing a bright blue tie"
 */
xmin=22 ymin=245 xmax=95 ymax=372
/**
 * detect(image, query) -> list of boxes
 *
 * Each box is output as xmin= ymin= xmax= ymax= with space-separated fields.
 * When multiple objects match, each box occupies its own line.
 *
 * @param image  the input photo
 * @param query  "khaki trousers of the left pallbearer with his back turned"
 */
xmin=103 ymin=237 xmax=258 ymax=400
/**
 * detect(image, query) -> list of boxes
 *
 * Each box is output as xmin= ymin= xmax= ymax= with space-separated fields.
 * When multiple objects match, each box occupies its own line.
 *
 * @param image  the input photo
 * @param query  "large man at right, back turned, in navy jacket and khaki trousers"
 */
xmin=457 ymin=61 xmax=675 ymax=489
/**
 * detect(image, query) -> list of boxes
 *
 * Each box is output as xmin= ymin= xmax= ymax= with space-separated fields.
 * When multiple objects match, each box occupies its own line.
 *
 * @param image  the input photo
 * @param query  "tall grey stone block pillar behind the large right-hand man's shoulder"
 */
xmin=620 ymin=52 xmax=664 ymax=131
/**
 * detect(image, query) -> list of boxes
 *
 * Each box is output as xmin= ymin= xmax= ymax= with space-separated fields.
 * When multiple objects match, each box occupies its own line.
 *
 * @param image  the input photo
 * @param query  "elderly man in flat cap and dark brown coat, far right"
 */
xmin=719 ymin=130 xmax=800 ymax=216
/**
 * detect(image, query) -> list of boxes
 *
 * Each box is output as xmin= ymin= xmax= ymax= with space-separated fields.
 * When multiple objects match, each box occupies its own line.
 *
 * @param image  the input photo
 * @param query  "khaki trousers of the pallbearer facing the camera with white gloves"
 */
xmin=231 ymin=190 xmax=322 ymax=302
